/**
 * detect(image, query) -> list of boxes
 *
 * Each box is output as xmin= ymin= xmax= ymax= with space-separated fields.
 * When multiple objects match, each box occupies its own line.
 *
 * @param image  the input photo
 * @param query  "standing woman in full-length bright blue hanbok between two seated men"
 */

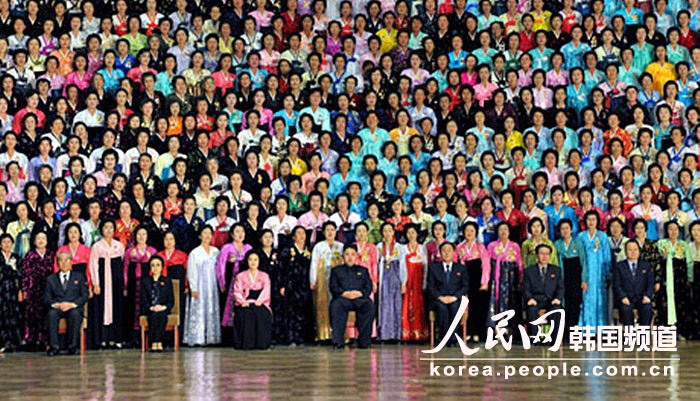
xmin=576 ymin=211 xmax=610 ymax=333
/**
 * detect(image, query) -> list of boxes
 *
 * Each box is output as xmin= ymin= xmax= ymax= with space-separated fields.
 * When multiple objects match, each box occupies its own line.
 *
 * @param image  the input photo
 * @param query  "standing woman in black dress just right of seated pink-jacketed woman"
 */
xmin=273 ymin=226 xmax=316 ymax=345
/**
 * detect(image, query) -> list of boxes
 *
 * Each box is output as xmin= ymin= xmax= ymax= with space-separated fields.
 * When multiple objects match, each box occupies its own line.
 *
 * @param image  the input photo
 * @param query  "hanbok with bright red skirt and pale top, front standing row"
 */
xmin=401 ymin=244 xmax=428 ymax=341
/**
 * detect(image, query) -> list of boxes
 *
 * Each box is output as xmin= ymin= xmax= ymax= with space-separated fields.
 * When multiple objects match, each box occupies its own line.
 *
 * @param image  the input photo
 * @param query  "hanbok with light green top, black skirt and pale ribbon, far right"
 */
xmin=656 ymin=239 xmax=694 ymax=337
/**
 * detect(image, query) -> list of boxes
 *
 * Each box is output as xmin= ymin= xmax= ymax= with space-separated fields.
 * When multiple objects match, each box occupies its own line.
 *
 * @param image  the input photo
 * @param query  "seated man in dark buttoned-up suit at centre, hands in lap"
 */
xmin=329 ymin=245 xmax=374 ymax=349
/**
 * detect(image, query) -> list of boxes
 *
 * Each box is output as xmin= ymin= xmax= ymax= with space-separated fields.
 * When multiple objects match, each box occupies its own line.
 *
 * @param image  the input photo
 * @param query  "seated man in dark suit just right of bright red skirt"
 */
xmin=427 ymin=242 xmax=469 ymax=346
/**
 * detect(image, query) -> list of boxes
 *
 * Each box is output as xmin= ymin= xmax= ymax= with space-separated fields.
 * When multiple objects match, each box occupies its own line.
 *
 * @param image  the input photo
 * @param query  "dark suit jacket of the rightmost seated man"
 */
xmin=613 ymin=259 xmax=654 ymax=305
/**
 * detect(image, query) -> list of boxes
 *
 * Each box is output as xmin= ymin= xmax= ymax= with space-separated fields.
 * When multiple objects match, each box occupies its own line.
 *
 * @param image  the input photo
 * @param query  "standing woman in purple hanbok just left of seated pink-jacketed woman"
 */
xmin=216 ymin=223 xmax=253 ymax=327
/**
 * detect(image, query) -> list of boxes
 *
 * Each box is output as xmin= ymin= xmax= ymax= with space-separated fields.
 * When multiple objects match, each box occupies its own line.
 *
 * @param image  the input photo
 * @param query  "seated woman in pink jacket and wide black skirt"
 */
xmin=233 ymin=251 xmax=272 ymax=350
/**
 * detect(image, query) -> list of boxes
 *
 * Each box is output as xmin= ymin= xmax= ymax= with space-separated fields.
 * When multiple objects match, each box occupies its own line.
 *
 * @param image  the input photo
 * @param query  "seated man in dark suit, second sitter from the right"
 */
xmin=523 ymin=244 xmax=564 ymax=337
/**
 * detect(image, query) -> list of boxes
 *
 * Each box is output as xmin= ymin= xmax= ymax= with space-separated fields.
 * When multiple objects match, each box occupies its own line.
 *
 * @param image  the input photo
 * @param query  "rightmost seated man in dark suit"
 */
xmin=613 ymin=241 xmax=654 ymax=326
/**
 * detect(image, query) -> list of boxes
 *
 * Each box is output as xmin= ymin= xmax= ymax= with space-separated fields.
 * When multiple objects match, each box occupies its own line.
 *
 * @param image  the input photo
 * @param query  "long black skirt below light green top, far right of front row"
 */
xmin=656 ymin=258 xmax=693 ymax=337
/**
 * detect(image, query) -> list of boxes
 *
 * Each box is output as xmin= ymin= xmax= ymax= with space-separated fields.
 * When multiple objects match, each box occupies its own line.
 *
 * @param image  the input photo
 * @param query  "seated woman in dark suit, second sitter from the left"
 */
xmin=141 ymin=255 xmax=175 ymax=352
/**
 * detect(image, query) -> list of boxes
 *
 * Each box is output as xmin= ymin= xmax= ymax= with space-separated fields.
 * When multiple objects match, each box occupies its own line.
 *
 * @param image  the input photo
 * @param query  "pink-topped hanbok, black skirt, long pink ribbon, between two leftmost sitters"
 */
xmin=88 ymin=239 xmax=124 ymax=345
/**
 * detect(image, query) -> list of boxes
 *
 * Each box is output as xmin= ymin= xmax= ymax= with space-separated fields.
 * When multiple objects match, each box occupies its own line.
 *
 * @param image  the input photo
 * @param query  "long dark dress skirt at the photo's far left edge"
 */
xmin=0 ymin=265 xmax=22 ymax=348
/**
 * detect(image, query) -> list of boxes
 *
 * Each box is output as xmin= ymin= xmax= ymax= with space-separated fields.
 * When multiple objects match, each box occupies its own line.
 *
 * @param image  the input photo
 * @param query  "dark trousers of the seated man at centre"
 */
xmin=330 ymin=297 xmax=374 ymax=347
